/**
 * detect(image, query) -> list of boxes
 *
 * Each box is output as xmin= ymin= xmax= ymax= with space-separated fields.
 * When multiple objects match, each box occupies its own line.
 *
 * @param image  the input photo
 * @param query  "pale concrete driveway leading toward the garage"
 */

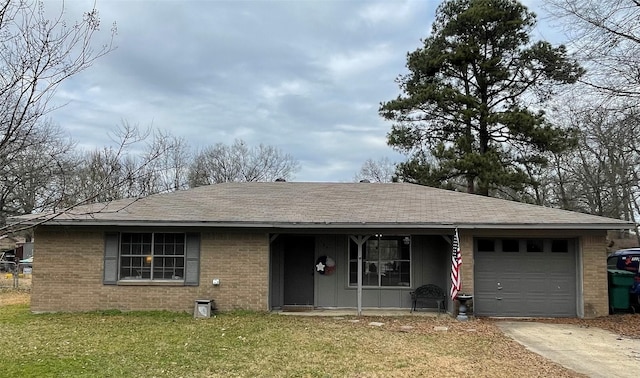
xmin=496 ymin=321 xmax=640 ymax=378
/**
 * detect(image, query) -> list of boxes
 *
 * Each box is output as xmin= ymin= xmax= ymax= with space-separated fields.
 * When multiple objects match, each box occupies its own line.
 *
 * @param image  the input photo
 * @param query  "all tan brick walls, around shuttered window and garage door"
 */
xmin=31 ymin=227 xmax=608 ymax=317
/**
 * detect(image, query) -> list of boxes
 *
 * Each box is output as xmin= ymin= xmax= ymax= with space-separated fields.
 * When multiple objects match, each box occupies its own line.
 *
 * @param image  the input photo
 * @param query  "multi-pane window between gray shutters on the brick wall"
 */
xmin=118 ymin=232 xmax=186 ymax=280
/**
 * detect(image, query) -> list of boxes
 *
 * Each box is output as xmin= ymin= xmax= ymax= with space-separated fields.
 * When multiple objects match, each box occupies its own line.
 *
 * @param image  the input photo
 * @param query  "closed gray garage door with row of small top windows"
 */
xmin=473 ymin=239 xmax=576 ymax=317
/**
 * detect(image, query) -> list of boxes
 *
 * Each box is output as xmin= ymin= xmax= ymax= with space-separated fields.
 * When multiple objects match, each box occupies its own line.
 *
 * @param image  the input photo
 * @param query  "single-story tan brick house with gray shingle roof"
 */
xmin=14 ymin=182 xmax=633 ymax=317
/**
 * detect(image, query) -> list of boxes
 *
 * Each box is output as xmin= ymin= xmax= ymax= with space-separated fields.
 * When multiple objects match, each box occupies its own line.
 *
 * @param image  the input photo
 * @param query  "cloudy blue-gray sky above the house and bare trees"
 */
xmin=45 ymin=0 xmax=555 ymax=182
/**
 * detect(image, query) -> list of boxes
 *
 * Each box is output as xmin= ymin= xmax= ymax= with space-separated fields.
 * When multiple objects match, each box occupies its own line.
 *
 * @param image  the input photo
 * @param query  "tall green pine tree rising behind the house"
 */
xmin=380 ymin=0 xmax=584 ymax=195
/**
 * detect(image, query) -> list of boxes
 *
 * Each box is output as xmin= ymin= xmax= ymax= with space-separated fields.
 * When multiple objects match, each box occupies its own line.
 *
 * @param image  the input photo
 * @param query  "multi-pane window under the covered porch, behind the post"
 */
xmin=349 ymin=235 xmax=411 ymax=287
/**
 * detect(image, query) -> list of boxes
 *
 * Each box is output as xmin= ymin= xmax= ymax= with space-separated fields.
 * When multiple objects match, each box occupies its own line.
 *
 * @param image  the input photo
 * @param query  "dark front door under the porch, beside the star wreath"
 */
xmin=283 ymin=235 xmax=315 ymax=306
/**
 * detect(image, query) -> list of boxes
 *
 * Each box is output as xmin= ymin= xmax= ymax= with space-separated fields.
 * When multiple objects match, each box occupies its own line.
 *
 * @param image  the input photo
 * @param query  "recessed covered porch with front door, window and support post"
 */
xmin=269 ymin=230 xmax=453 ymax=315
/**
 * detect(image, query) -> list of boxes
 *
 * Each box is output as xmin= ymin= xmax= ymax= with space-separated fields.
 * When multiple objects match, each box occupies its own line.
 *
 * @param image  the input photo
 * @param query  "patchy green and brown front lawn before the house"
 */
xmin=0 ymin=304 xmax=580 ymax=377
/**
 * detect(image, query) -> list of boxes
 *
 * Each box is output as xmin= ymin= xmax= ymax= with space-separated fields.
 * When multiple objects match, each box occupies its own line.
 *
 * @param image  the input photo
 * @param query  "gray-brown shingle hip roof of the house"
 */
xmin=12 ymin=182 xmax=632 ymax=229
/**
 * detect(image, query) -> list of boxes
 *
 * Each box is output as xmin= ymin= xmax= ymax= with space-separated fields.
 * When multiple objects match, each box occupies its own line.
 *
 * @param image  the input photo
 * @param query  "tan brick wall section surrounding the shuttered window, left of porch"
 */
xmin=31 ymin=227 xmax=269 ymax=312
